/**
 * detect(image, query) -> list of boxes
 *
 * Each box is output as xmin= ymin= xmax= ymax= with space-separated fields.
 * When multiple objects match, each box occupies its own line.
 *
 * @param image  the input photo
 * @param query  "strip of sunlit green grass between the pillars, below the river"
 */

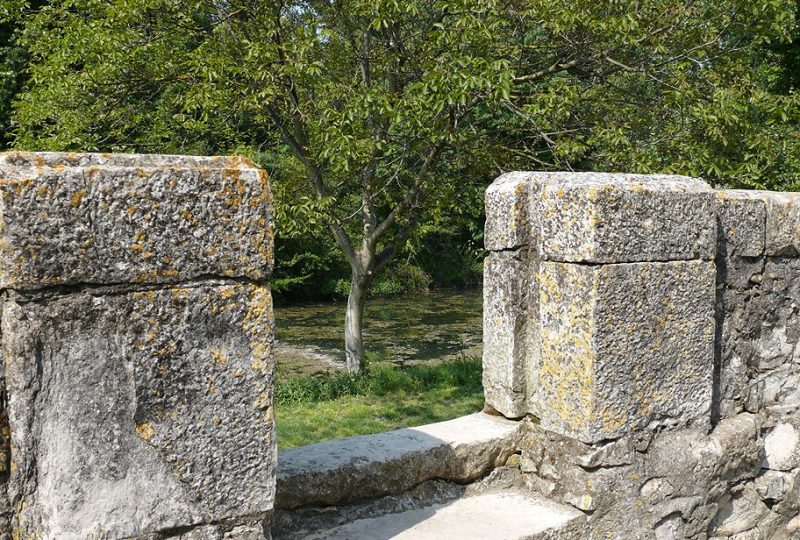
xmin=275 ymin=358 xmax=483 ymax=449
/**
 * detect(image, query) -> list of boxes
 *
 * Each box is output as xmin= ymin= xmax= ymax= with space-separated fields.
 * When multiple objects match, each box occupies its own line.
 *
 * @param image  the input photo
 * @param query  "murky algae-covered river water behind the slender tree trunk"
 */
xmin=275 ymin=290 xmax=483 ymax=376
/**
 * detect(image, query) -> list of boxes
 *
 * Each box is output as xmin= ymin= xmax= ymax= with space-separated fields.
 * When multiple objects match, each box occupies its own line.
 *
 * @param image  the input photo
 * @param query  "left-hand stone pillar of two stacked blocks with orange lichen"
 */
xmin=0 ymin=153 xmax=276 ymax=539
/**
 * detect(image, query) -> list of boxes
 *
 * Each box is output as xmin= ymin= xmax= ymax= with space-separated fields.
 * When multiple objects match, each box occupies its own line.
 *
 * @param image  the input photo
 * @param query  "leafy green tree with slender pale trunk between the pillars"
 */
xmin=7 ymin=0 xmax=800 ymax=371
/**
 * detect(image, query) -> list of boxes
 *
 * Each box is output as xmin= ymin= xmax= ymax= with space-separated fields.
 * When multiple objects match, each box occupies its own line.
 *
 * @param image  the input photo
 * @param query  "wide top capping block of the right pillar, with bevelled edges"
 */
xmin=530 ymin=173 xmax=716 ymax=263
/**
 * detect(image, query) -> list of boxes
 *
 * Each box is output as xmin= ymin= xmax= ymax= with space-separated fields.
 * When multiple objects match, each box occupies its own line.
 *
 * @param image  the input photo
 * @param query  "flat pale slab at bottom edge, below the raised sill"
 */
xmin=307 ymin=491 xmax=583 ymax=540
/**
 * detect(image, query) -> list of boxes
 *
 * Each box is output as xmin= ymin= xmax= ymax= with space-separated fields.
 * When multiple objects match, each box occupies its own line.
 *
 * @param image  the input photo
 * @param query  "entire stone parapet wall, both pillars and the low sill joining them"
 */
xmin=0 ymin=153 xmax=800 ymax=540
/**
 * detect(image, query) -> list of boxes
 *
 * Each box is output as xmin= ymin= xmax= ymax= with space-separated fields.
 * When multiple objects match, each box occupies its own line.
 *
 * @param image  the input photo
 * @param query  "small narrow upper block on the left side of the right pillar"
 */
xmin=483 ymin=172 xmax=534 ymax=251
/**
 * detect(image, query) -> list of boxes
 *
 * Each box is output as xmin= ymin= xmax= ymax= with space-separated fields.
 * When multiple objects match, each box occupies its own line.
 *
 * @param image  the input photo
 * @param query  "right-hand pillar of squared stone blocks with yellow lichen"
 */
xmin=484 ymin=173 xmax=716 ymax=443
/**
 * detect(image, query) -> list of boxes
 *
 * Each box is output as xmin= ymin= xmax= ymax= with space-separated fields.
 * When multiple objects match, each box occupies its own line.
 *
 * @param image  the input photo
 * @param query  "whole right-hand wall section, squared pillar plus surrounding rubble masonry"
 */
xmin=484 ymin=173 xmax=800 ymax=539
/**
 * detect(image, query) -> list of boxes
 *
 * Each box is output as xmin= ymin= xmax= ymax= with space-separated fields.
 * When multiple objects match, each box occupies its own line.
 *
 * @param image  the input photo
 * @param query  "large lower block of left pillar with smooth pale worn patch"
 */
xmin=2 ymin=281 xmax=276 ymax=539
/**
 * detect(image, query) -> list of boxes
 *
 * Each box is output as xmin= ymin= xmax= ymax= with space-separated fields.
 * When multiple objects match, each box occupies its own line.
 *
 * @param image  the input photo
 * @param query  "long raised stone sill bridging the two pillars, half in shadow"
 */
xmin=276 ymin=413 xmax=522 ymax=509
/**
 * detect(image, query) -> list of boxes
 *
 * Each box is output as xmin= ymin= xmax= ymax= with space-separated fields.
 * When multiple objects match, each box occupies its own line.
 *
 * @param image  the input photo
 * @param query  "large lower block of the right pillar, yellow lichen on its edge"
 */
xmin=529 ymin=261 xmax=715 ymax=442
